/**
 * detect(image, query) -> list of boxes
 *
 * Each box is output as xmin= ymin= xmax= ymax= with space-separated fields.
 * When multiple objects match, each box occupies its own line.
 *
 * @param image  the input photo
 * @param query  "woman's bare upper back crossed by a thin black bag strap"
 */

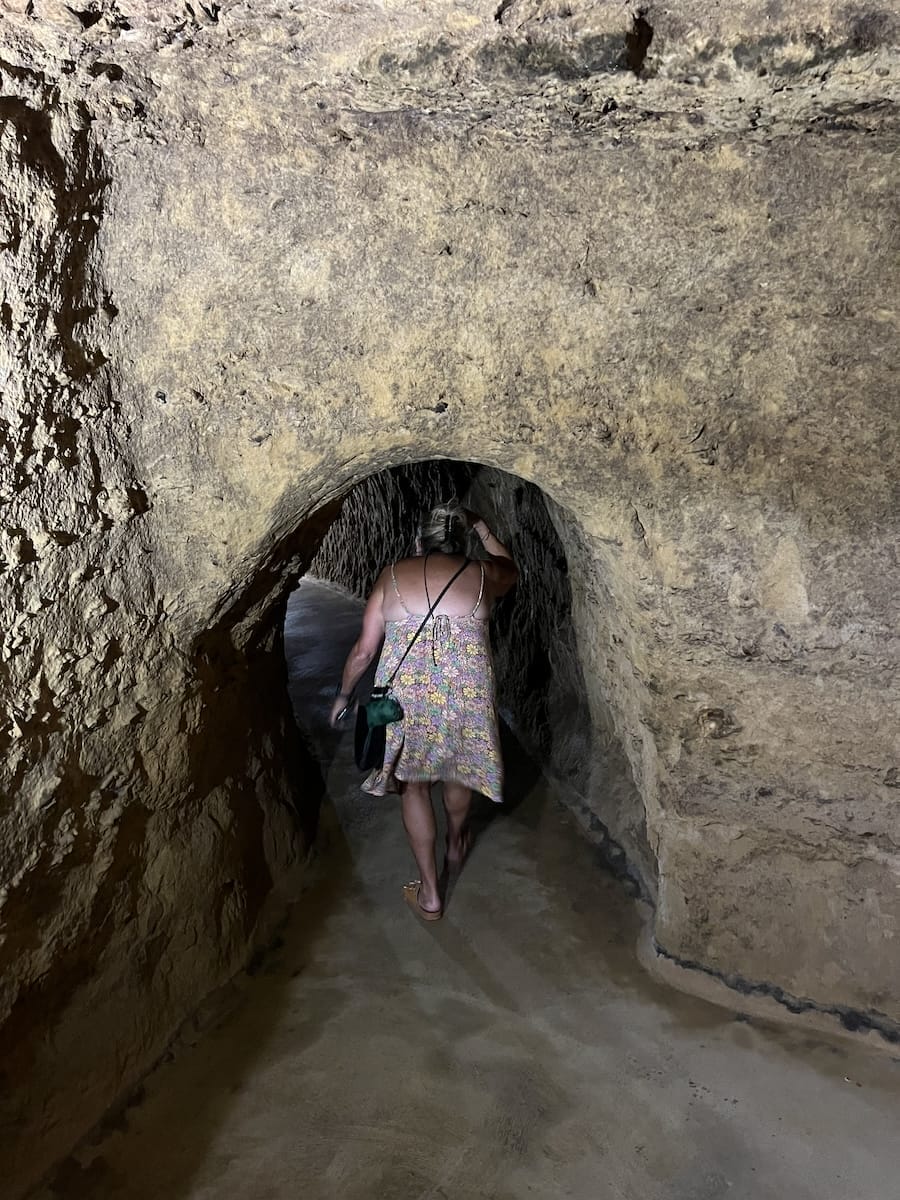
xmin=382 ymin=553 xmax=493 ymax=620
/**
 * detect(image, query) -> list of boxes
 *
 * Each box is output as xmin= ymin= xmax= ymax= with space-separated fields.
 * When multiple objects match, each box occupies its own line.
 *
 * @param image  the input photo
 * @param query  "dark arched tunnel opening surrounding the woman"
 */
xmin=284 ymin=460 xmax=655 ymax=900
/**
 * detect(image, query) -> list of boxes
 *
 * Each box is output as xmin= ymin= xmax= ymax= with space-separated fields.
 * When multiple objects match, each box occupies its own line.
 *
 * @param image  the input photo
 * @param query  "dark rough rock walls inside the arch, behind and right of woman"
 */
xmin=296 ymin=460 xmax=656 ymax=898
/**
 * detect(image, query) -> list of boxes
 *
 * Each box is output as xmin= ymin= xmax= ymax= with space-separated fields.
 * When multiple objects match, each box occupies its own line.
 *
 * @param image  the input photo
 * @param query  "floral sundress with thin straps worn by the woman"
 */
xmin=362 ymin=566 xmax=503 ymax=804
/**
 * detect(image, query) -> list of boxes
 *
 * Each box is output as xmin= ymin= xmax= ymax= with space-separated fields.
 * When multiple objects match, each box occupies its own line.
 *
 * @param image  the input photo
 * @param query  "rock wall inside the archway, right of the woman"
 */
xmin=468 ymin=469 xmax=656 ymax=900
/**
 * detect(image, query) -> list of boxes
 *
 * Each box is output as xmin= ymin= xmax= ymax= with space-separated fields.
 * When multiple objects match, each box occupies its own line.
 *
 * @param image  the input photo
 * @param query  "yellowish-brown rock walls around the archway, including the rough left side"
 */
xmin=0 ymin=0 xmax=900 ymax=1194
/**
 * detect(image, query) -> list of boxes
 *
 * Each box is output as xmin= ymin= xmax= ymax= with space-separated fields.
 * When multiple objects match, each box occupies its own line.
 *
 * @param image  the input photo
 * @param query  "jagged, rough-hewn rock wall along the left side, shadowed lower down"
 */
xmin=0 ymin=14 xmax=317 ymax=1180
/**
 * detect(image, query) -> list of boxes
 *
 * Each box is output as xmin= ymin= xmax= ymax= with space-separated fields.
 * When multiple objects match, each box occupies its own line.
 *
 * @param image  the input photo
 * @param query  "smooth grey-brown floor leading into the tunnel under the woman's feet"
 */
xmin=40 ymin=581 xmax=900 ymax=1200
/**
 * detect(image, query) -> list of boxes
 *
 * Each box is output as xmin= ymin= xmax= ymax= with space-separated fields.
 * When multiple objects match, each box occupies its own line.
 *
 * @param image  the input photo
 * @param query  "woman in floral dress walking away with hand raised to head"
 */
xmin=331 ymin=504 xmax=518 ymax=920
